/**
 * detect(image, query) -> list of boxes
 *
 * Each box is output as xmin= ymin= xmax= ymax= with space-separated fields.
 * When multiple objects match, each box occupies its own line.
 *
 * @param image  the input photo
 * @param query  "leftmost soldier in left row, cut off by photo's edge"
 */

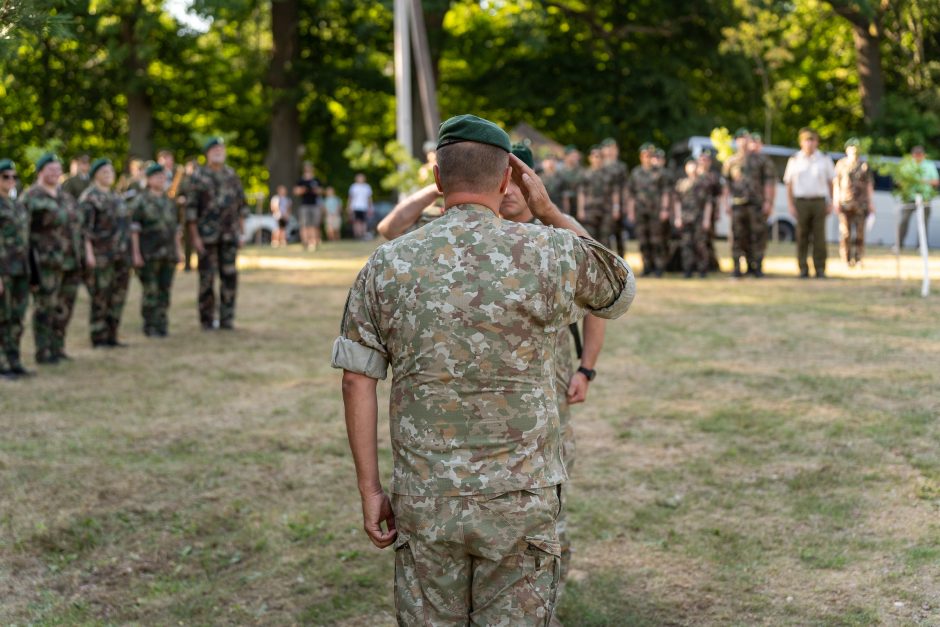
xmin=0 ymin=159 xmax=31 ymax=378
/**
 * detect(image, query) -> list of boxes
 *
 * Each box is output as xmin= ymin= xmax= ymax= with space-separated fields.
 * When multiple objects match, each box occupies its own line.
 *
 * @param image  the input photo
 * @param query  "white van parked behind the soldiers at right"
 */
xmin=669 ymin=136 xmax=940 ymax=247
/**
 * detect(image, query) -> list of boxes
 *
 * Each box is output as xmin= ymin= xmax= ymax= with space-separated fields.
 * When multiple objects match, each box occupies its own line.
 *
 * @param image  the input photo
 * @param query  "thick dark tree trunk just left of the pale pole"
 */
xmin=267 ymin=0 xmax=301 ymax=193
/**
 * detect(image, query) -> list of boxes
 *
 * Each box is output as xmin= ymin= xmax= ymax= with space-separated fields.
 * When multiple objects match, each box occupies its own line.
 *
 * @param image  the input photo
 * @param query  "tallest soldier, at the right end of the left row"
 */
xmin=186 ymin=137 xmax=248 ymax=330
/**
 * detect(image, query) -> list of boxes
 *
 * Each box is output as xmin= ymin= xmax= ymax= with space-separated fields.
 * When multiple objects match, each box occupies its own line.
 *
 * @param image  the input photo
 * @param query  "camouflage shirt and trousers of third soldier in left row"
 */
xmin=79 ymin=185 xmax=130 ymax=346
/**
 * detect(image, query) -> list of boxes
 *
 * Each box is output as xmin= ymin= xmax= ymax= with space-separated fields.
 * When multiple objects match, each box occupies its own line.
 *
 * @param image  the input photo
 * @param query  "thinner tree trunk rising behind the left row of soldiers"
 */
xmin=121 ymin=0 xmax=153 ymax=159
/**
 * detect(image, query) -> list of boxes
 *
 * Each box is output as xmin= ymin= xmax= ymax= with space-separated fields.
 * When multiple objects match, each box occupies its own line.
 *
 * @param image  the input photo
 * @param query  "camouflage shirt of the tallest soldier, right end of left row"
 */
xmin=186 ymin=165 xmax=248 ymax=244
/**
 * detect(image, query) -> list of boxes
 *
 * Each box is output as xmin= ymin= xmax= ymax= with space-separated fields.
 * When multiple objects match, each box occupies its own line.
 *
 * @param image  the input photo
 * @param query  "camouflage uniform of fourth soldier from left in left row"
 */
xmin=128 ymin=190 xmax=179 ymax=336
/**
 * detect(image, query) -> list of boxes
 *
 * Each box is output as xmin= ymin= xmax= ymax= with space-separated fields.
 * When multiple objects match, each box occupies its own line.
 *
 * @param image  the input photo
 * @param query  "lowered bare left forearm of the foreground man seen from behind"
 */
xmin=343 ymin=370 xmax=382 ymax=495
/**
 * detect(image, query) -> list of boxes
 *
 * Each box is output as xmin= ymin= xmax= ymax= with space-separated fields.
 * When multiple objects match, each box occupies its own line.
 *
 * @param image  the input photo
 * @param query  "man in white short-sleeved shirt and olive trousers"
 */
xmin=783 ymin=128 xmax=835 ymax=279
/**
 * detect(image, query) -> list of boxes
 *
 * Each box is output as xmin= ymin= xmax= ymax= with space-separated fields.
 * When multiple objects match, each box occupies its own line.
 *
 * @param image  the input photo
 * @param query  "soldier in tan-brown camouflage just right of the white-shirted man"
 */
xmin=832 ymin=137 xmax=875 ymax=267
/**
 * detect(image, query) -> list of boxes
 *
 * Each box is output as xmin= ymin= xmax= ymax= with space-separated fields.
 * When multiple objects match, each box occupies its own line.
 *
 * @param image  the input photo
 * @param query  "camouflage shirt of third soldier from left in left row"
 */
xmin=78 ymin=185 xmax=130 ymax=261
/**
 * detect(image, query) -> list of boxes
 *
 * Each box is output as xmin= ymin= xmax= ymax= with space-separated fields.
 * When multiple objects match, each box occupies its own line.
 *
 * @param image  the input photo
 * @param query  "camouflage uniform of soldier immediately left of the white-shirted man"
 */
xmin=721 ymin=153 xmax=767 ymax=270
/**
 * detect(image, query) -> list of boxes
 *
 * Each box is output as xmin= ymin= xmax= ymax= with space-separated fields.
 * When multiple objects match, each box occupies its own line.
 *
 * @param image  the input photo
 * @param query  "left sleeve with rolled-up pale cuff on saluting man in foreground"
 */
xmin=331 ymin=259 xmax=388 ymax=379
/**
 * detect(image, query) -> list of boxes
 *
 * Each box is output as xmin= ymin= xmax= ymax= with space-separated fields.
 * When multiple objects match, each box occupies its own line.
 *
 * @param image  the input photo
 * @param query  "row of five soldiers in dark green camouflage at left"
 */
xmin=0 ymin=137 xmax=248 ymax=378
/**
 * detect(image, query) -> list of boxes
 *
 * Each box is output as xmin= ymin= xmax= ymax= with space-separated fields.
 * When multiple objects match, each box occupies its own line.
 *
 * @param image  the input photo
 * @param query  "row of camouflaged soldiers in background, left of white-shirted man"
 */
xmin=542 ymin=129 xmax=776 ymax=277
